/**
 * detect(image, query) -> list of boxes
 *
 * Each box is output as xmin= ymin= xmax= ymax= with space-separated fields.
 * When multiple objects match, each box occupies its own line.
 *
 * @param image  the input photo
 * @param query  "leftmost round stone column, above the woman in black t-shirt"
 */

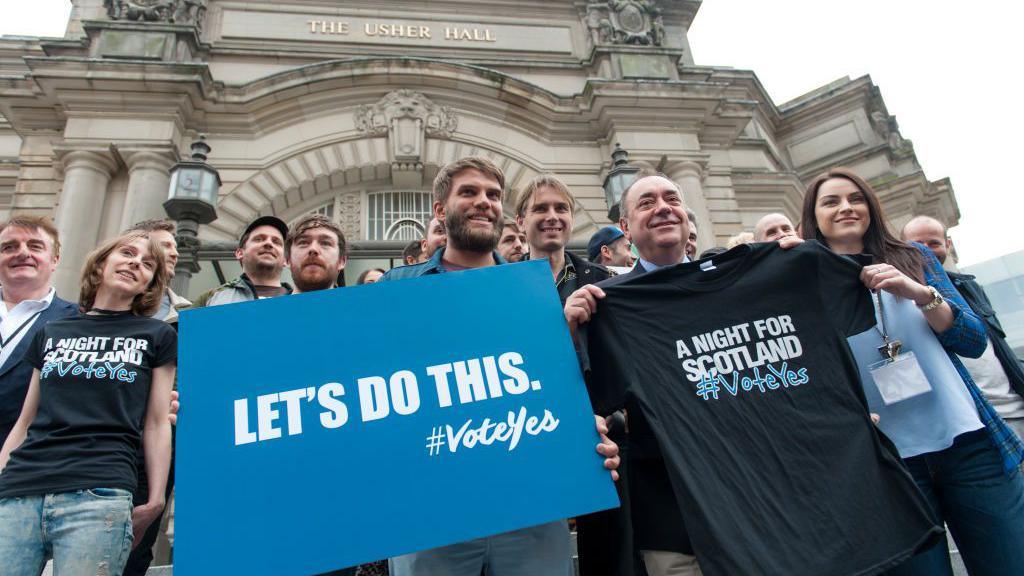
xmin=53 ymin=150 xmax=117 ymax=301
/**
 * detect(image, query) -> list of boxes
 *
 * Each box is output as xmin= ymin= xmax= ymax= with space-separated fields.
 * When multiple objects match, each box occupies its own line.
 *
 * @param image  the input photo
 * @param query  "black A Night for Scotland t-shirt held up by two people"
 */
xmin=583 ymin=242 xmax=942 ymax=576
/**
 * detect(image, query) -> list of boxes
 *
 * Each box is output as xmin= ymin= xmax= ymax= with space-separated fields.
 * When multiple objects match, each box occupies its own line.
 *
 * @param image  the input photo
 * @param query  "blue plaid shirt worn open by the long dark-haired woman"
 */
xmin=912 ymin=242 xmax=1024 ymax=472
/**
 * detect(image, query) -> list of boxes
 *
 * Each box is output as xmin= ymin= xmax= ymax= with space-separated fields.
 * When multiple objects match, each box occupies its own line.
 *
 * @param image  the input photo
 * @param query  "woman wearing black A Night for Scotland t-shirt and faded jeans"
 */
xmin=0 ymin=233 xmax=177 ymax=576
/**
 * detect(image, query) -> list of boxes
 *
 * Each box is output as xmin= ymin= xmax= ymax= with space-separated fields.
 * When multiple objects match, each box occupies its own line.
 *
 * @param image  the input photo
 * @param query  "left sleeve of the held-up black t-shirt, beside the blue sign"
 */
xmin=578 ymin=301 xmax=628 ymax=416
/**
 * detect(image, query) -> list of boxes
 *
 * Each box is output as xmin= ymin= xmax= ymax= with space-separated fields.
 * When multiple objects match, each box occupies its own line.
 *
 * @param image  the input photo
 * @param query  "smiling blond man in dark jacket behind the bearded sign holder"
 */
xmin=516 ymin=174 xmax=611 ymax=304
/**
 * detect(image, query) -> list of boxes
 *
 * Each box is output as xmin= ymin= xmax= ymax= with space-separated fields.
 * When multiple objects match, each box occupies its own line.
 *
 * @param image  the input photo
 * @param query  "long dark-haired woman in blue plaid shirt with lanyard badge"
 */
xmin=802 ymin=168 xmax=1024 ymax=576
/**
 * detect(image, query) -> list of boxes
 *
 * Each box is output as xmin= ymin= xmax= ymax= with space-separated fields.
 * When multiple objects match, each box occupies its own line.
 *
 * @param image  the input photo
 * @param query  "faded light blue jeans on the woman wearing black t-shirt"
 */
xmin=0 ymin=488 xmax=132 ymax=576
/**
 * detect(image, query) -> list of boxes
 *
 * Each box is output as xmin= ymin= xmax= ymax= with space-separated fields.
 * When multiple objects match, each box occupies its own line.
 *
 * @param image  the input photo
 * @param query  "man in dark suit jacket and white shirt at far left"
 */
xmin=0 ymin=216 xmax=78 ymax=445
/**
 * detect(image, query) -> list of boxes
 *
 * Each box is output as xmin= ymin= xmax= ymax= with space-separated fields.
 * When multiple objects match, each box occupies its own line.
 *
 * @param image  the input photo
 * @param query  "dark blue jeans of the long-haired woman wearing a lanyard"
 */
xmin=889 ymin=428 xmax=1024 ymax=576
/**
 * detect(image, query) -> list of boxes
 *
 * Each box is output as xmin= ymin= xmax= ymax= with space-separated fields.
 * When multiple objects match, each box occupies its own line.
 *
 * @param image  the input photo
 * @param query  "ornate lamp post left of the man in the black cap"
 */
xmin=164 ymin=134 xmax=220 ymax=295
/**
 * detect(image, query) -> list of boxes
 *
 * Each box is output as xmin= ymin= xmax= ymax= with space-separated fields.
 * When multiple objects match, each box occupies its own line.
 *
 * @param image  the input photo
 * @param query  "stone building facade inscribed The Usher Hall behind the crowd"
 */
xmin=0 ymin=0 xmax=958 ymax=297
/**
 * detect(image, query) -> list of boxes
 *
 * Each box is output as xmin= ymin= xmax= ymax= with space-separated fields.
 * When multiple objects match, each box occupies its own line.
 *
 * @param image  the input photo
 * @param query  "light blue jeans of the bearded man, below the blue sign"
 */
xmin=390 ymin=520 xmax=572 ymax=576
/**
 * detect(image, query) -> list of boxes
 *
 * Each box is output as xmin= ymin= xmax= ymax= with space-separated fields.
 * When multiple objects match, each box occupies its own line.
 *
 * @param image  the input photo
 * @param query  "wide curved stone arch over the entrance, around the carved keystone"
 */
xmin=204 ymin=57 xmax=602 ymax=239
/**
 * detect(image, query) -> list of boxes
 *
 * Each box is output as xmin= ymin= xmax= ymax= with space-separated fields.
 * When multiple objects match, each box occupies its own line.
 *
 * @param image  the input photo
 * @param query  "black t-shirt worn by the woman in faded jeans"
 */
xmin=0 ymin=313 xmax=177 ymax=497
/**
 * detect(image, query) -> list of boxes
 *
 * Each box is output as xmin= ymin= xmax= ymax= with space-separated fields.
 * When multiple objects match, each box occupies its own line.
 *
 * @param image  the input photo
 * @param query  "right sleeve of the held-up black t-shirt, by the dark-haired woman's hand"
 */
xmin=809 ymin=242 xmax=876 ymax=336
